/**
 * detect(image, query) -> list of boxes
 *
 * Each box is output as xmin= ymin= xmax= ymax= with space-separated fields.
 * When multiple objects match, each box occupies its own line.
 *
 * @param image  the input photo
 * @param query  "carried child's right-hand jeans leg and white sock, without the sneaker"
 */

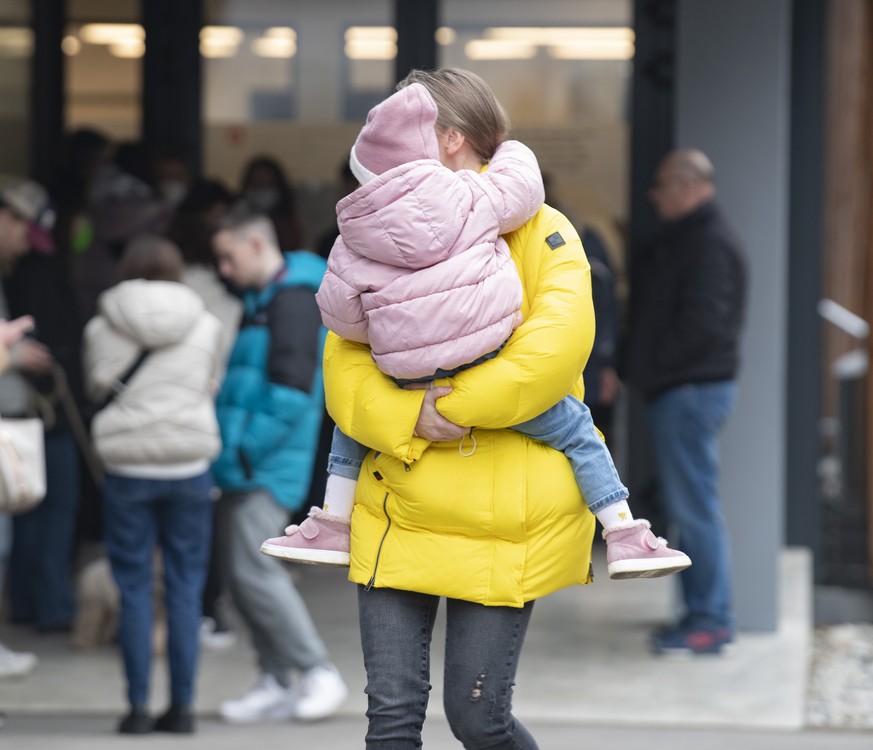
xmin=513 ymin=396 xmax=633 ymax=528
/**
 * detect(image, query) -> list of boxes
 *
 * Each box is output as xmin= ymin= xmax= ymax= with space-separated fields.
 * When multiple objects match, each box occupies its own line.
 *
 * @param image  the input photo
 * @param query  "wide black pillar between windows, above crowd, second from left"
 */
xmin=141 ymin=0 xmax=202 ymax=174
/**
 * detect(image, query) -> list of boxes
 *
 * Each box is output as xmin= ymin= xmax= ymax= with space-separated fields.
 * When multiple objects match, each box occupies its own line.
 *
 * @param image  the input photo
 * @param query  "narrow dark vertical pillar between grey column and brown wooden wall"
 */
xmin=785 ymin=0 xmax=826 ymax=581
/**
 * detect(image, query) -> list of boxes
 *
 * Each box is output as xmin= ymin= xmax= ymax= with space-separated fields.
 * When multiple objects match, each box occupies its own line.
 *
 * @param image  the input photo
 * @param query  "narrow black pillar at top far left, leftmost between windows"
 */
xmin=30 ymin=0 xmax=67 ymax=184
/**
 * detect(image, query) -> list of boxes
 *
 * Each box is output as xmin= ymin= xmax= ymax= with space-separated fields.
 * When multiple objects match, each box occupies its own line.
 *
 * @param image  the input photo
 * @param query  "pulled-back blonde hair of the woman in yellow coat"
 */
xmin=397 ymin=68 xmax=510 ymax=161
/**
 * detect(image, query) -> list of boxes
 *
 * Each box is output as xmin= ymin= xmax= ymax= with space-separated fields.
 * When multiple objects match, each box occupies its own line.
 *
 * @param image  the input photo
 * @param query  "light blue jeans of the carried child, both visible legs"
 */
xmin=327 ymin=396 xmax=629 ymax=513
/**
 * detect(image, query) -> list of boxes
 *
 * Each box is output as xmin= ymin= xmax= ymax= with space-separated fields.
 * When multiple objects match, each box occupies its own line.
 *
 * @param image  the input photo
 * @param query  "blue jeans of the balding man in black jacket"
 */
xmin=648 ymin=380 xmax=736 ymax=633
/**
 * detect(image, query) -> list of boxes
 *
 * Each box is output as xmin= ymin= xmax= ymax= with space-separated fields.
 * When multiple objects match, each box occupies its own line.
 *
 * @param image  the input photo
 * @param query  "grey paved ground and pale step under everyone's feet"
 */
xmin=0 ymin=550 xmax=873 ymax=750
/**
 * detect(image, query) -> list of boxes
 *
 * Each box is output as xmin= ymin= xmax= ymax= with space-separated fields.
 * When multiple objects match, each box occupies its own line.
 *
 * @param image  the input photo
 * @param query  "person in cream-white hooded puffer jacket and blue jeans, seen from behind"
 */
xmin=84 ymin=236 xmax=223 ymax=734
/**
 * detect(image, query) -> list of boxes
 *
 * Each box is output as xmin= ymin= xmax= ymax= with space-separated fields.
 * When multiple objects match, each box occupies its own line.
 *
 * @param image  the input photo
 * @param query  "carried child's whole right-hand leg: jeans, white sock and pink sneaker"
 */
xmin=514 ymin=396 xmax=691 ymax=578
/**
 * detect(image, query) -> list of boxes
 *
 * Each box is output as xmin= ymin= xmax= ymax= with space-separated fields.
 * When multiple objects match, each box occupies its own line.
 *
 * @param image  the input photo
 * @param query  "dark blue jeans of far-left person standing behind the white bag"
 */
xmin=9 ymin=431 xmax=79 ymax=631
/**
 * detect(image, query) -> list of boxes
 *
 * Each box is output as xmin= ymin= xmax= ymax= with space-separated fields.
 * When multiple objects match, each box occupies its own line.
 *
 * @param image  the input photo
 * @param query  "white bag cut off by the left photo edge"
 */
xmin=0 ymin=418 xmax=45 ymax=513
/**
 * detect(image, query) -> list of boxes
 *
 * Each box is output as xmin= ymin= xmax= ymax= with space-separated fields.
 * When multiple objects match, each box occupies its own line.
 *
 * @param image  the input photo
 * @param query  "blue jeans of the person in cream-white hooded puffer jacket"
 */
xmin=103 ymin=472 xmax=213 ymax=708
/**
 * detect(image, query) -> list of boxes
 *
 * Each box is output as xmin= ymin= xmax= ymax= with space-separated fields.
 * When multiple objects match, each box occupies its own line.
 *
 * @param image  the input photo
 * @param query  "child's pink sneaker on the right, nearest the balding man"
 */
xmin=603 ymin=518 xmax=691 ymax=578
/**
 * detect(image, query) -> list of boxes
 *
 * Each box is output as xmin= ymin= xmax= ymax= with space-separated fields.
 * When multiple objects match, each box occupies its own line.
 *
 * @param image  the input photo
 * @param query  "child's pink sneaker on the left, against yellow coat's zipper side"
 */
xmin=261 ymin=508 xmax=351 ymax=567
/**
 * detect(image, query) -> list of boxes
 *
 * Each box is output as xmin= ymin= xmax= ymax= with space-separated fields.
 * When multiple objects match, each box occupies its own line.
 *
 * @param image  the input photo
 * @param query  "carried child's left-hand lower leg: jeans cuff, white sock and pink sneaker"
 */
xmin=261 ymin=427 xmax=369 ymax=566
